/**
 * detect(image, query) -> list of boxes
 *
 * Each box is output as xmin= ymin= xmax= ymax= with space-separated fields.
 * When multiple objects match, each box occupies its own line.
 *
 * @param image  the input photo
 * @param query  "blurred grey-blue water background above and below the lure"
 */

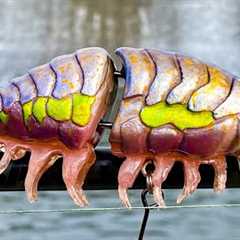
xmin=0 ymin=0 xmax=240 ymax=240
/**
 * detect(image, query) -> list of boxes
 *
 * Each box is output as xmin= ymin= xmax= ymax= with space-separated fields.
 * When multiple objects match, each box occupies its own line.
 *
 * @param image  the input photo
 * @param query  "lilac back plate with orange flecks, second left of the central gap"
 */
xmin=50 ymin=55 xmax=83 ymax=99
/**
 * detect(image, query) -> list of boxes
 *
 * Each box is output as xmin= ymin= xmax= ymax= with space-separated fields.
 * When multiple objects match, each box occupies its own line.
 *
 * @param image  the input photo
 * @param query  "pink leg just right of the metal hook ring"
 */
xmin=152 ymin=155 xmax=175 ymax=207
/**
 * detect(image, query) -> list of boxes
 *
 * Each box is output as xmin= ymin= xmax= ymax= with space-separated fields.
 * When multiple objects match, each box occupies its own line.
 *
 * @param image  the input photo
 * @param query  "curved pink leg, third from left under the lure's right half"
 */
xmin=177 ymin=156 xmax=201 ymax=204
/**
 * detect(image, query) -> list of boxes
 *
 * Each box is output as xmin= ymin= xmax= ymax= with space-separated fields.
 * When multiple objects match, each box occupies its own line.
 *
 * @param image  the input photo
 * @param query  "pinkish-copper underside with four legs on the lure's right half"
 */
xmin=118 ymin=152 xmax=227 ymax=207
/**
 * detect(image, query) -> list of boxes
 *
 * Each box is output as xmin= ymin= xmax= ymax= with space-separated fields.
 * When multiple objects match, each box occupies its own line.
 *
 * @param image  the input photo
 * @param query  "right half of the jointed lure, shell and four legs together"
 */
xmin=110 ymin=48 xmax=240 ymax=206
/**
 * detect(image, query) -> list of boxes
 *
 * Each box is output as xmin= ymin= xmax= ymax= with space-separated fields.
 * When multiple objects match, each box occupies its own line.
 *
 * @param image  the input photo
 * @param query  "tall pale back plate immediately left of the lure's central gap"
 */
xmin=76 ymin=48 xmax=108 ymax=96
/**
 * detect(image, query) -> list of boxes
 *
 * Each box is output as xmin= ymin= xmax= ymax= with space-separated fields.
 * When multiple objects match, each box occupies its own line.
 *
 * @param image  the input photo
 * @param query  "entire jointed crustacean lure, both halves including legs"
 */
xmin=0 ymin=48 xmax=240 ymax=207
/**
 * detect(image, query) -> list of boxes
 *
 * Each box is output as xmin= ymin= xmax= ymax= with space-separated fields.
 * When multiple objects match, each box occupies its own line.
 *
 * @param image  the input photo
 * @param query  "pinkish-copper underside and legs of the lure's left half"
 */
xmin=0 ymin=135 xmax=95 ymax=206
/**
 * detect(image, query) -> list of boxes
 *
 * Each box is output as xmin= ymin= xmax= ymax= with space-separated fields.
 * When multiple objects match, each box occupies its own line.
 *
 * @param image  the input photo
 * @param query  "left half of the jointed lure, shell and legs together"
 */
xmin=0 ymin=48 xmax=114 ymax=206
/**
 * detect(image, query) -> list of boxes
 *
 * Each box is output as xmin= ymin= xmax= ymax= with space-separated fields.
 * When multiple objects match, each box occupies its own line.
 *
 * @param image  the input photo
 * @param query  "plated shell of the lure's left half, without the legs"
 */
xmin=0 ymin=48 xmax=113 ymax=145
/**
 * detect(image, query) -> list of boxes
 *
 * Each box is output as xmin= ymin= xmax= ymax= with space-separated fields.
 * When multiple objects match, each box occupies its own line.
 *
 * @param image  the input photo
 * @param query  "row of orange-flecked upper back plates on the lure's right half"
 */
xmin=116 ymin=48 xmax=240 ymax=118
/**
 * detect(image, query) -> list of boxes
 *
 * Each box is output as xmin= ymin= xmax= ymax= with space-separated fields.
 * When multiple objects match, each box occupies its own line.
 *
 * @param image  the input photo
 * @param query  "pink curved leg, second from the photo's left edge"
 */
xmin=25 ymin=146 xmax=60 ymax=202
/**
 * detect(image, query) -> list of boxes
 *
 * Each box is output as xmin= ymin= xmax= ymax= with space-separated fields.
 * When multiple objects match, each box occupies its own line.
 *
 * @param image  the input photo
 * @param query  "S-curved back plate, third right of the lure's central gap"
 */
xmin=167 ymin=56 xmax=208 ymax=104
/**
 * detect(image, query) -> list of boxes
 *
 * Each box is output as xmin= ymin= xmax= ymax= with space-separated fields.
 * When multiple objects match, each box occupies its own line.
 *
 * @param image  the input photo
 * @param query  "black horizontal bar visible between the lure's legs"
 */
xmin=0 ymin=148 xmax=240 ymax=191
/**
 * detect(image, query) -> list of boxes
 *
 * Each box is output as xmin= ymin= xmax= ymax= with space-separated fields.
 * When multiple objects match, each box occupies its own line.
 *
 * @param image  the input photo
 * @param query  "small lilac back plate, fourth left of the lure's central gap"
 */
xmin=12 ymin=74 xmax=37 ymax=104
